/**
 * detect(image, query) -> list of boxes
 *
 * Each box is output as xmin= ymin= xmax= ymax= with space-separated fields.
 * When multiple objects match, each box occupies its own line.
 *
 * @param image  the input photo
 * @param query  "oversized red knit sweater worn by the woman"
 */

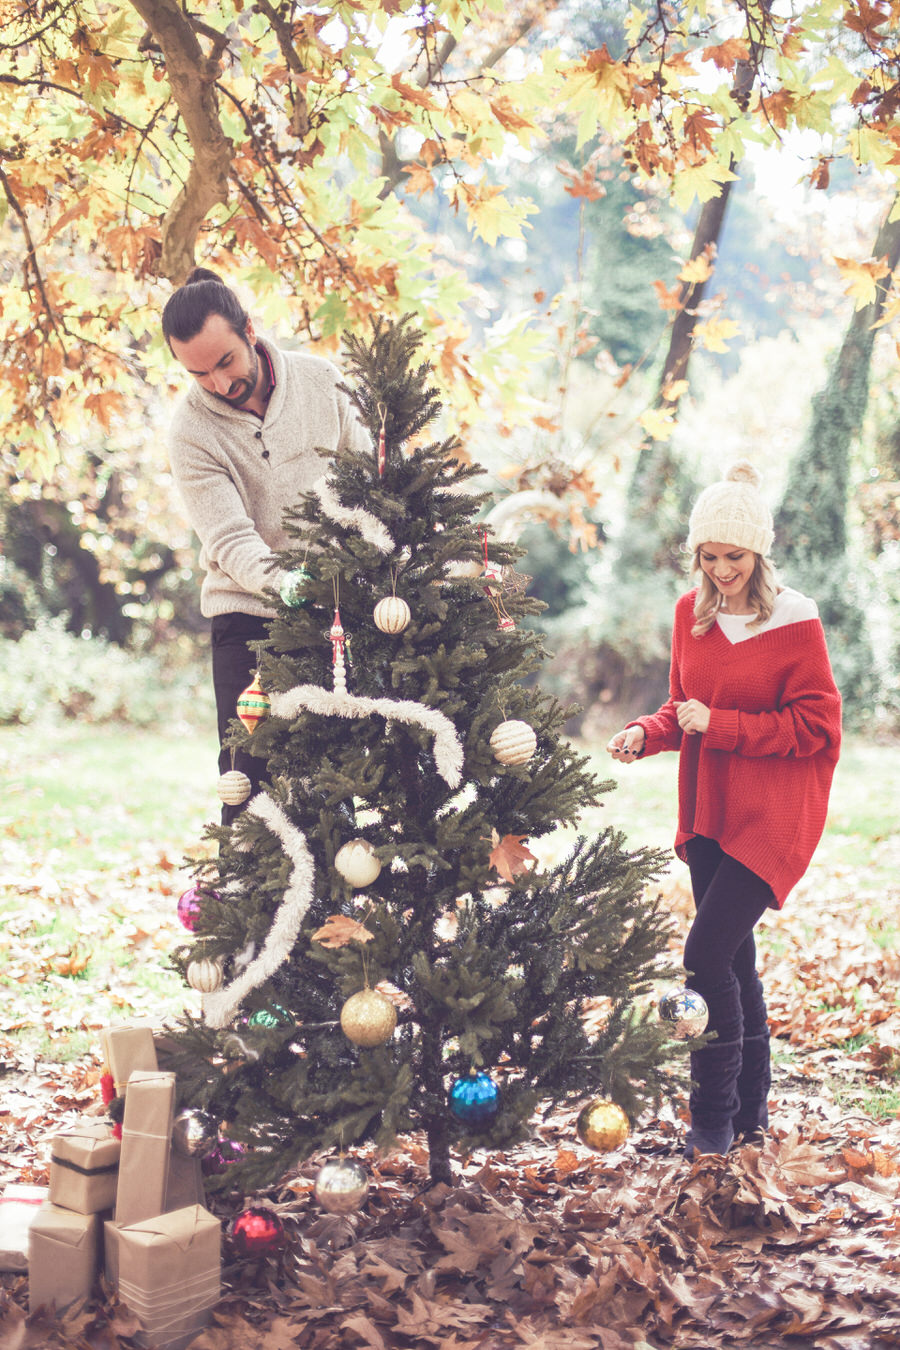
xmin=631 ymin=591 xmax=841 ymax=909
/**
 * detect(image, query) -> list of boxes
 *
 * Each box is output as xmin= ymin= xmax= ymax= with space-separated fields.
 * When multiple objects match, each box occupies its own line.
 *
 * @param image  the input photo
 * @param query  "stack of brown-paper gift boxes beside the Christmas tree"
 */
xmin=28 ymin=1027 xmax=221 ymax=1350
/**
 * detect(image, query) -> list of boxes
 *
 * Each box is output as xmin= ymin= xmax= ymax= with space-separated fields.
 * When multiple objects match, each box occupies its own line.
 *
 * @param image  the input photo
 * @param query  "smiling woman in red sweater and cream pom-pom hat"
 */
xmin=607 ymin=460 xmax=841 ymax=1158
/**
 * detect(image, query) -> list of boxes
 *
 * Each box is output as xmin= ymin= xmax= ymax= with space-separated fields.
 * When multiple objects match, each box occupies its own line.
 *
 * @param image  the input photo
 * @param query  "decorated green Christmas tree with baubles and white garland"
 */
xmin=168 ymin=320 xmax=672 ymax=1188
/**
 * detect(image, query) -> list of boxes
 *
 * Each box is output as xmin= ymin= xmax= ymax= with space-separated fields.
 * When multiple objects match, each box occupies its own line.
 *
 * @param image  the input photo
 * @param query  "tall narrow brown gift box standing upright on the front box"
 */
xmin=115 ymin=1069 xmax=175 ymax=1223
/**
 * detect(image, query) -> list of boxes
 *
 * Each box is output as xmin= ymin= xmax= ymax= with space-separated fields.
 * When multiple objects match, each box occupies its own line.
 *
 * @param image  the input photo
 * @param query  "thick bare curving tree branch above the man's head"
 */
xmin=131 ymin=0 xmax=232 ymax=284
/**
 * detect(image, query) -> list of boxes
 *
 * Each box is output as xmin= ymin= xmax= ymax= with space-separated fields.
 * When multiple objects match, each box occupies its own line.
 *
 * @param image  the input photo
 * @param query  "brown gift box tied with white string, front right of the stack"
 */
xmin=112 ymin=1204 xmax=221 ymax=1347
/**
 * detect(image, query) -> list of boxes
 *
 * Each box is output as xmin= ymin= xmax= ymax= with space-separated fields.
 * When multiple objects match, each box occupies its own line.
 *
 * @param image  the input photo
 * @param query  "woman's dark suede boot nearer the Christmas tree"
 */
xmin=684 ymin=980 xmax=743 ymax=1158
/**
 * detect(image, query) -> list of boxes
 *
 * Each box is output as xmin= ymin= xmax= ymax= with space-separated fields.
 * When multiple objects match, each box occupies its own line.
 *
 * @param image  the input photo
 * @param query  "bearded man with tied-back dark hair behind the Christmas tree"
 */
xmin=162 ymin=267 xmax=370 ymax=825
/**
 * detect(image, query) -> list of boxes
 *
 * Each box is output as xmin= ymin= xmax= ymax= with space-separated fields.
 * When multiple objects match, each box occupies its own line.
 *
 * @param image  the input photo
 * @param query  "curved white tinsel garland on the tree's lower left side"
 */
xmin=202 ymin=792 xmax=316 ymax=1027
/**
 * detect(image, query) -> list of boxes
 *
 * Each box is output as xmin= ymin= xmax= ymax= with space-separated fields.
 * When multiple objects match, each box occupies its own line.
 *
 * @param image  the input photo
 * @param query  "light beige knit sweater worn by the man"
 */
xmin=170 ymin=340 xmax=371 ymax=617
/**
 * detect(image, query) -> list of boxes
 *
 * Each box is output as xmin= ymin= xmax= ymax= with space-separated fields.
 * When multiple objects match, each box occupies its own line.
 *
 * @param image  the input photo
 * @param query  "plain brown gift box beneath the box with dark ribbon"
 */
xmin=28 ymin=1200 xmax=100 ymax=1312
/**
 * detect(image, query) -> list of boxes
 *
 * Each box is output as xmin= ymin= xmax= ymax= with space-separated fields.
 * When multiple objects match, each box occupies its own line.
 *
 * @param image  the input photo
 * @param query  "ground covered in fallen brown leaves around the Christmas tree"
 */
xmin=0 ymin=748 xmax=900 ymax=1350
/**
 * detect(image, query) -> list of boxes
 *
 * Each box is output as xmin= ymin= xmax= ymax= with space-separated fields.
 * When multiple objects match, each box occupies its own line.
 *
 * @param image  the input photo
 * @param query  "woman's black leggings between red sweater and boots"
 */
xmin=684 ymin=834 xmax=773 ymax=1038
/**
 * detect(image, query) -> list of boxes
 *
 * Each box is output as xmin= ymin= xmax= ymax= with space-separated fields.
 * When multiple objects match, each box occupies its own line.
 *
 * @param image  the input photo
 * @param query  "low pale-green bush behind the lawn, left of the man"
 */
xmin=0 ymin=617 xmax=215 ymax=729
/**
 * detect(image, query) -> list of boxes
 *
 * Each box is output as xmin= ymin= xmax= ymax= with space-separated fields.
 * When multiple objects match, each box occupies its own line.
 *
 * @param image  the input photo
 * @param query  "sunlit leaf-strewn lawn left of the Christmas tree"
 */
xmin=0 ymin=724 xmax=220 ymax=1062
